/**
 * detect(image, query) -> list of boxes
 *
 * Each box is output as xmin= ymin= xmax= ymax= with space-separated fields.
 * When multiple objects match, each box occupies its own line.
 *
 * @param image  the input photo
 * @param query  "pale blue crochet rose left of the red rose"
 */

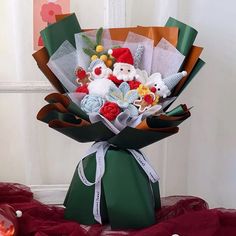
xmin=81 ymin=95 xmax=104 ymax=113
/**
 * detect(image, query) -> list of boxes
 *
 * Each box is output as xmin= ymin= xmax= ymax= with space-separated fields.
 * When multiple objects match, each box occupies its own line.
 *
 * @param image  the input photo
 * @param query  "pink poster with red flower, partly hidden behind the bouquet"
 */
xmin=33 ymin=0 xmax=70 ymax=50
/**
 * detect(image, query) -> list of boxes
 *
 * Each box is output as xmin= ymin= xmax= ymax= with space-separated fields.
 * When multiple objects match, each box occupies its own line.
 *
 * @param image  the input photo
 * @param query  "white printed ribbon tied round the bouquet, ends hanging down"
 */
xmin=78 ymin=142 xmax=160 ymax=224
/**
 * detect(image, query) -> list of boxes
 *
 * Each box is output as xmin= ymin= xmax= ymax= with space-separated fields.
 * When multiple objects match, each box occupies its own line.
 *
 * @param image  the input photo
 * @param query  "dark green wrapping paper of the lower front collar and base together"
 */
xmin=37 ymin=93 xmax=187 ymax=229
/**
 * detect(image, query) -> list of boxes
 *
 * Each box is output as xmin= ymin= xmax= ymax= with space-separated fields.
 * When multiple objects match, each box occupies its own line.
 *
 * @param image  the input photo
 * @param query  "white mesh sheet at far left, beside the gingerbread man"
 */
xmin=47 ymin=41 xmax=77 ymax=92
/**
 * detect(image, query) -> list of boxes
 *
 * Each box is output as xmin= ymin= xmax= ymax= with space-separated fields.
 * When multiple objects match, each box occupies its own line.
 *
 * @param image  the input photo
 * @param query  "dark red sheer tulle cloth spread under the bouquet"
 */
xmin=0 ymin=183 xmax=236 ymax=236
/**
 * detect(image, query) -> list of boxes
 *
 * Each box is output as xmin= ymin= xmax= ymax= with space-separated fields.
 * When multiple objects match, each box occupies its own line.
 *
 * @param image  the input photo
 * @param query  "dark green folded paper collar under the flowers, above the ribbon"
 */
xmin=37 ymin=104 xmax=178 ymax=149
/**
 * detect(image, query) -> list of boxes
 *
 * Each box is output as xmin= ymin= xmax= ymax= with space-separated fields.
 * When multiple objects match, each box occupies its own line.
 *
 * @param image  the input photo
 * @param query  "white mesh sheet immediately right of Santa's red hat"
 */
xmin=123 ymin=32 xmax=154 ymax=75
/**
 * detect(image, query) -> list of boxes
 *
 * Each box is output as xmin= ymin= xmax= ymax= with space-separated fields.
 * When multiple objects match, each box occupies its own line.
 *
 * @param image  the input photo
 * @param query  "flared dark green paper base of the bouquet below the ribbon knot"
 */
xmin=64 ymin=147 xmax=161 ymax=229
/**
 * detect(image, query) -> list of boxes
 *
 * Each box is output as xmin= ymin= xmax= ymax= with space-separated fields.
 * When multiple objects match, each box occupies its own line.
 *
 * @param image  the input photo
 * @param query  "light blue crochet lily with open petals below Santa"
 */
xmin=106 ymin=82 xmax=139 ymax=116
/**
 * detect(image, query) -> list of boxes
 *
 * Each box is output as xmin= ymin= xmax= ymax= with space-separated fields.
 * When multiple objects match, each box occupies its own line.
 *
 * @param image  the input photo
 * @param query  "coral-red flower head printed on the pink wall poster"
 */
xmin=40 ymin=2 xmax=62 ymax=24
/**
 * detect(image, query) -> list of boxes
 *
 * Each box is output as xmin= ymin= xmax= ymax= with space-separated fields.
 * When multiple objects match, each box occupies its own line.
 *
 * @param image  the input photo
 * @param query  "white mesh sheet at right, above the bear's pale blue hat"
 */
xmin=152 ymin=38 xmax=185 ymax=78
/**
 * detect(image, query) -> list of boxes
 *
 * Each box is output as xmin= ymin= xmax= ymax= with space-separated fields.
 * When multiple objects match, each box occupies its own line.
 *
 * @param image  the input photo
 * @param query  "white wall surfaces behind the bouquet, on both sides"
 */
xmin=0 ymin=0 xmax=236 ymax=208
